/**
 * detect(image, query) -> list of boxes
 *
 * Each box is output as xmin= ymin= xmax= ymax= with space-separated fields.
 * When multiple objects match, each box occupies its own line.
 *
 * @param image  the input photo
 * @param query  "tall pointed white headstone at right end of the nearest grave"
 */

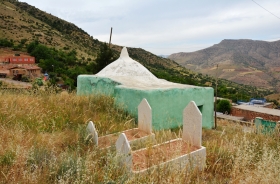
xmin=182 ymin=101 xmax=202 ymax=148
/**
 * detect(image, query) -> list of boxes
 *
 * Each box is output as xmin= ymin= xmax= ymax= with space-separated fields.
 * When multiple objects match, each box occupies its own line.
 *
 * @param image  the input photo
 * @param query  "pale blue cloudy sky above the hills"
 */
xmin=22 ymin=0 xmax=280 ymax=55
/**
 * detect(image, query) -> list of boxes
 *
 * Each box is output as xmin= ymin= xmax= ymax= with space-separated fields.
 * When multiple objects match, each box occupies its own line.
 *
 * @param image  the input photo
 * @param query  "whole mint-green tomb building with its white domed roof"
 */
xmin=77 ymin=47 xmax=214 ymax=130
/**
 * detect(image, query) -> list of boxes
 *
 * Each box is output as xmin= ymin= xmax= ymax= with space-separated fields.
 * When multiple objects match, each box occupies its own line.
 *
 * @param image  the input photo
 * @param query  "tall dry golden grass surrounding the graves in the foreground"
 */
xmin=0 ymin=92 xmax=280 ymax=183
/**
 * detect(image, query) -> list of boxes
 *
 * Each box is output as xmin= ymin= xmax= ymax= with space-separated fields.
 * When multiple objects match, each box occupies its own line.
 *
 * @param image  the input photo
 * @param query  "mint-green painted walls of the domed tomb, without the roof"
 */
xmin=77 ymin=75 xmax=214 ymax=130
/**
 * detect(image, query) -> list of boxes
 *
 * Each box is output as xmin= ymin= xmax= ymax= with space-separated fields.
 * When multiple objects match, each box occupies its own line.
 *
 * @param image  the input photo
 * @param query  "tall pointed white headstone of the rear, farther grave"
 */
xmin=138 ymin=98 xmax=152 ymax=134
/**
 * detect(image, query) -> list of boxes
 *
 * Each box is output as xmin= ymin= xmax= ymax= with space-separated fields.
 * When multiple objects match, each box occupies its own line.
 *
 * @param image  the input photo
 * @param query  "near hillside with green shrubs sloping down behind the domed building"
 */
xmin=0 ymin=0 xmax=272 ymax=101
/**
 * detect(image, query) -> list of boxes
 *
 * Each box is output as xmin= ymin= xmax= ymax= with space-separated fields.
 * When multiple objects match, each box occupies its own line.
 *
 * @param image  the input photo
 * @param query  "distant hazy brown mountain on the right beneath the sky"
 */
xmin=168 ymin=39 xmax=280 ymax=91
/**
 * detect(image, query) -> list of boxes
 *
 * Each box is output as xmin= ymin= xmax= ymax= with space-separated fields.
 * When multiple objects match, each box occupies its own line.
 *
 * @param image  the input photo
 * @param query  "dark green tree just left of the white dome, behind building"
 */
xmin=94 ymin=43 xmax=117 ymax=73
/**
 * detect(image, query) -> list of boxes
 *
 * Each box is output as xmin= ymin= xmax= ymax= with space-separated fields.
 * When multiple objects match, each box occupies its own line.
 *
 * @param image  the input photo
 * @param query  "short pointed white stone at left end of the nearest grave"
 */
xmin=116 ymin=133 xmax=132 ymax=169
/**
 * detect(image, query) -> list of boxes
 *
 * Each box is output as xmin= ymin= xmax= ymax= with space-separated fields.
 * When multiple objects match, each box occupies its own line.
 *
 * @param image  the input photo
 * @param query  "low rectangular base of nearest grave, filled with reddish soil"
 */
xmin=130 ymin=138 xmax=206 ymax=174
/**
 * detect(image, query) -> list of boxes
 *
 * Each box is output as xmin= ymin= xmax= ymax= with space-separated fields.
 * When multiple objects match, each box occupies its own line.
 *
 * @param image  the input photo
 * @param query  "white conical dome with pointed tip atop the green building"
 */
xmin=96 ymin=47 xmax=157 ymax=79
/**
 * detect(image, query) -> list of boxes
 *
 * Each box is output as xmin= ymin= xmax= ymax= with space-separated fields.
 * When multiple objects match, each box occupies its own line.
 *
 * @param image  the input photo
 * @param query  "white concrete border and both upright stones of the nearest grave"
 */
xmin=116 ymin=101 xmax=206 ymax=174
